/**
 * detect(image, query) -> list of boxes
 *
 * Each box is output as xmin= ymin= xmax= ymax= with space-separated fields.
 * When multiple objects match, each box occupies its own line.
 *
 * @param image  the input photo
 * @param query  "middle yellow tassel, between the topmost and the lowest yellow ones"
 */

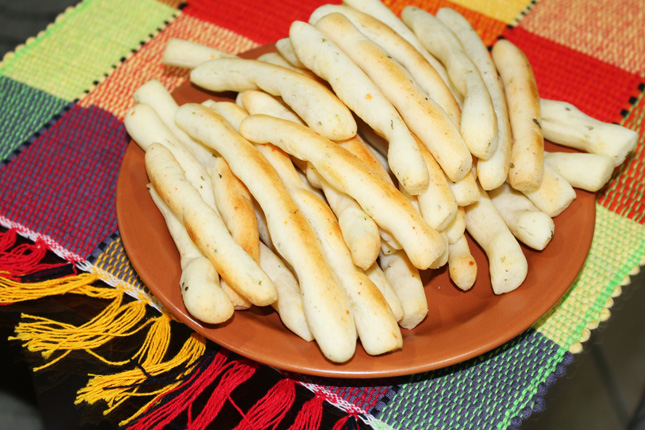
xmin=10 ymin=288 xmax=152 ymax=371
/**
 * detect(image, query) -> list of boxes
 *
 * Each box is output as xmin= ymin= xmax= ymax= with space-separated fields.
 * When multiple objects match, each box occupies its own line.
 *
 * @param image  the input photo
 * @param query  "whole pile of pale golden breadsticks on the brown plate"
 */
xmin=125 ymin=0 xmax=638 ymax=362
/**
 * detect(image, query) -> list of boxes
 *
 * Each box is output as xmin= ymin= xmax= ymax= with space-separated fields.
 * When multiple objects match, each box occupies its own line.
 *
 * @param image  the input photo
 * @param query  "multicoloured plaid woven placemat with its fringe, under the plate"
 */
xmin=0 ymin=0 xmax=645 ymax=429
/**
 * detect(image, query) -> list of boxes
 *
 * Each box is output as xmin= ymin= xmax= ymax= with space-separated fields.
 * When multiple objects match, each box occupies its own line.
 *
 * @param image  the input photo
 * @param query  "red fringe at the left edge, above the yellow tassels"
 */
xmin=0 ymin=228 xmax=69 ymax=281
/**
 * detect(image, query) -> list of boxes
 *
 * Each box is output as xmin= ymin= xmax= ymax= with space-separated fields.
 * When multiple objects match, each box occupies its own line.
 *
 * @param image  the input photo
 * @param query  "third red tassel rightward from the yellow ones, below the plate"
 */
xmin=234 ymin=379 xmax=296 ymax=430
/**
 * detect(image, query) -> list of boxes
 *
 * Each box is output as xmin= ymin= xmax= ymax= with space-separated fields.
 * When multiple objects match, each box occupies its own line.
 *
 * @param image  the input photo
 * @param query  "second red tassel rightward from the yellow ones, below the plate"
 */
xmin=187 ymin=361 xmax=257 ymax=430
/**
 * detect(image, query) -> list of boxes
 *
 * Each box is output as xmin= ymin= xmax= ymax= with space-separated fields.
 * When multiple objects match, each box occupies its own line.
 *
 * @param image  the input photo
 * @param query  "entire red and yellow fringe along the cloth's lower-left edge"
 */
xmin=0 ymin=228 xmax=375 ymax=430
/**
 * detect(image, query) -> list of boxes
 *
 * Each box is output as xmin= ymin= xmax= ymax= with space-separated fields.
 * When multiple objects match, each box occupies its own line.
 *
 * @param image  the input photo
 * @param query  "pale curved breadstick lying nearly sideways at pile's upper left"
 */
xmin=190 ymin=58 xmax=356 ymax=140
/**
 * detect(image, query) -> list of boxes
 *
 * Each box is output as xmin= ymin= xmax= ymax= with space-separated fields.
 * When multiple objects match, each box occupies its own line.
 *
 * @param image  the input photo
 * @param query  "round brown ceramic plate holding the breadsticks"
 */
xmin=117 ymin=47 xmax=595 ymax=378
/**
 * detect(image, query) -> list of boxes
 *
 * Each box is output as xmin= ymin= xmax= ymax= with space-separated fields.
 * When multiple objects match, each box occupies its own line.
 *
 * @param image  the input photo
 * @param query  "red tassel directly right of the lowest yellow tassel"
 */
xmin=128 ymin=351 xmax=228 ymax=430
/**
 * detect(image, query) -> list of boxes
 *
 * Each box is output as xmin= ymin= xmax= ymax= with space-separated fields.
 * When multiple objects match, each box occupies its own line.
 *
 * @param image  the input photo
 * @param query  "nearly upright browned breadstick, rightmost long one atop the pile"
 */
xmin=493 ymin=40 xmax=544 ymax=192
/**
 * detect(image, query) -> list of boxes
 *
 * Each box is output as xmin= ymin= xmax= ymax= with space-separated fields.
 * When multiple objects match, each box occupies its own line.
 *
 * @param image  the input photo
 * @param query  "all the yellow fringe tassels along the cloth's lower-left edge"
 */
xmin=0 ymin=273 xmax=206 ymax=425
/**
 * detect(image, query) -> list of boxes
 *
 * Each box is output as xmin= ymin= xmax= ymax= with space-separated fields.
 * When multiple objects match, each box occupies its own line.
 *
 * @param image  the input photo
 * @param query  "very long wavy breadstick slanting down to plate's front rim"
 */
xmin=176 ymin=103 xmax=356 ymax=362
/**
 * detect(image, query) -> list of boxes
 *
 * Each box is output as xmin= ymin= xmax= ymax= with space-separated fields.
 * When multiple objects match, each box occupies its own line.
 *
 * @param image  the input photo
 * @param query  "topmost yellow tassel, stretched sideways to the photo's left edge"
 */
xmin=0 ymin=273 xmax=100 ymax=303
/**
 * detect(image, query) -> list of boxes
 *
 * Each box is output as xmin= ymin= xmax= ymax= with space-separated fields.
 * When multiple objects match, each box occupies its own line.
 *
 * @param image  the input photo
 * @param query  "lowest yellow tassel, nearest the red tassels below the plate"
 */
xmin=75 ymin=330 xmax=206 ymax=425
